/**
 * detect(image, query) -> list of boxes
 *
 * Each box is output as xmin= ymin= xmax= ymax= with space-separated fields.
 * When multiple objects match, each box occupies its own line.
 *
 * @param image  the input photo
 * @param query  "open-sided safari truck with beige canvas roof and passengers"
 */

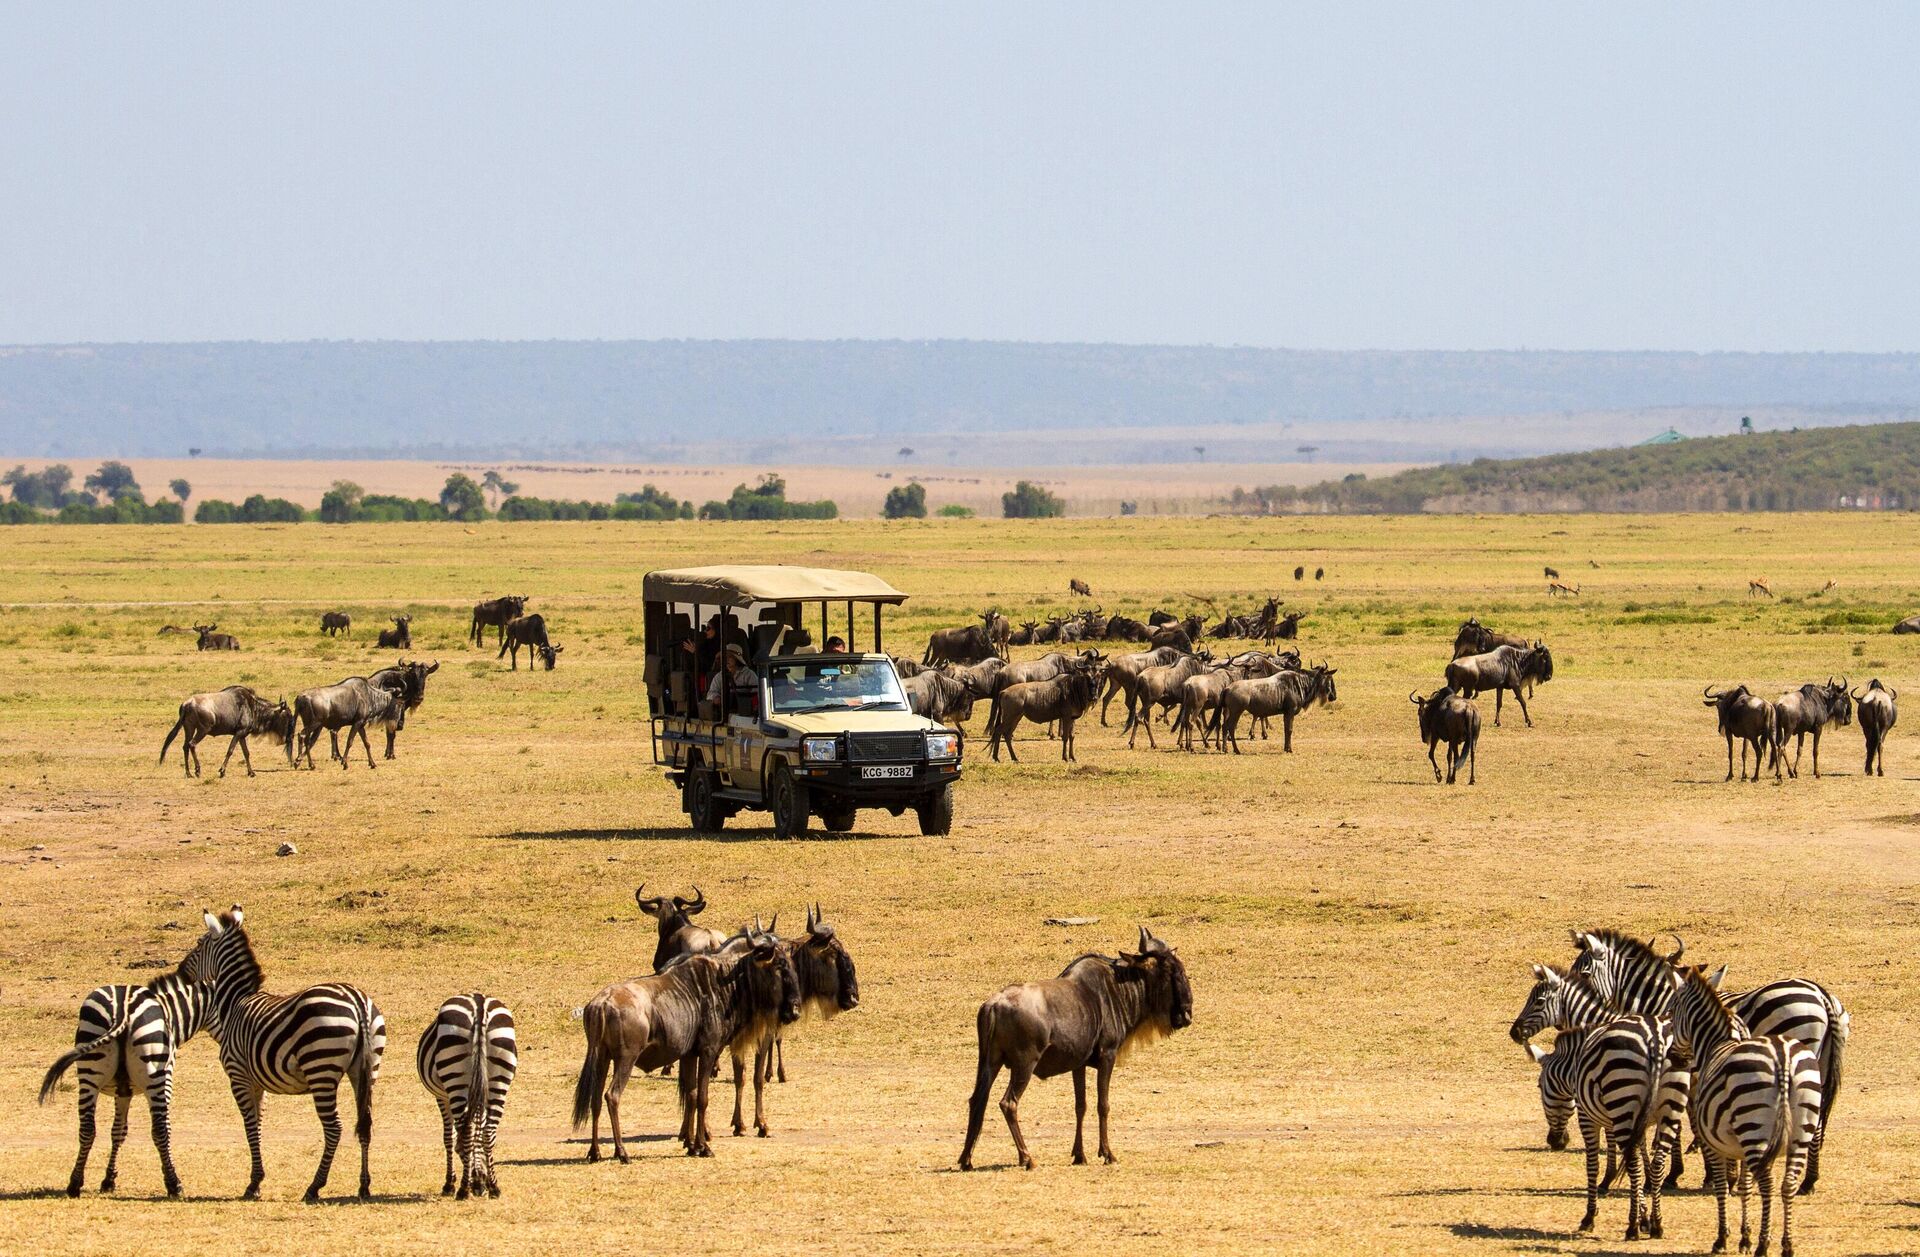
xmin=643 ymin=566 xmax=960 ymax=839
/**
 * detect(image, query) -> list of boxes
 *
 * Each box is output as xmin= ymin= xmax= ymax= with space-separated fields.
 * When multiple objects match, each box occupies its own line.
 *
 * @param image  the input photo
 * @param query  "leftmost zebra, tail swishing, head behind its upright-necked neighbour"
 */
xmin=40 ymin=965 xmax=211 ymax=1196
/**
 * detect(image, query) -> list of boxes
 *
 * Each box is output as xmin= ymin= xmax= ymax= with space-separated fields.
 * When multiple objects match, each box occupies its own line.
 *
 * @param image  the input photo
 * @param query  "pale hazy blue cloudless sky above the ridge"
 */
xmin=0 ymin=0 xmax=1920 ymax=351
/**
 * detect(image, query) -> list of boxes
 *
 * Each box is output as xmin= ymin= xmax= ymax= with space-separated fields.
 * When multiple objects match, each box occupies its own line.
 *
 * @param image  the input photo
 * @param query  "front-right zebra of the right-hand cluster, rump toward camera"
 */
xmin=1674 ymin=965 xmax=1820 ymax=1257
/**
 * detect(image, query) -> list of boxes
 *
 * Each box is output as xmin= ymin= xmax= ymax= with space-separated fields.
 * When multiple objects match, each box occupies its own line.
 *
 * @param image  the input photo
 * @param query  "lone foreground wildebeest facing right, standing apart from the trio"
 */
xmin=960 ymin=925 xmax=1194 ymax=1171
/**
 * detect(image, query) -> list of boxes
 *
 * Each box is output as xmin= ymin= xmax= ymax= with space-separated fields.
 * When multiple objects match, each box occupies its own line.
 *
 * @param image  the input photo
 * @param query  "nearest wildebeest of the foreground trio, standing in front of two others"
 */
xmin=574 ymin=933 xmax=801 ymax=1163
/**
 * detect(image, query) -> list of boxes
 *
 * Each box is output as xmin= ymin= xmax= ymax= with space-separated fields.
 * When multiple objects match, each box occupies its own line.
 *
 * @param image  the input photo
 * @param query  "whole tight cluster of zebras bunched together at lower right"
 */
xmin=1509 ymin=929 xmax=1851 ymax=1253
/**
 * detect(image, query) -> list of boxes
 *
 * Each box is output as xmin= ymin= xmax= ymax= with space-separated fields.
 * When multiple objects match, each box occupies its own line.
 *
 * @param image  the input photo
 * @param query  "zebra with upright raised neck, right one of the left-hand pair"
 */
xmin=182 ymin=904 xmax=386 ymax=1203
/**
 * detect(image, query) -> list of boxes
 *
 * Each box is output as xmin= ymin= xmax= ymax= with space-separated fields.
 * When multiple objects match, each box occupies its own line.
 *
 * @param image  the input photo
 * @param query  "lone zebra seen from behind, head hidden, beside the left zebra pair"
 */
xmin=415 ymin=990 xmax=520 ymax=1199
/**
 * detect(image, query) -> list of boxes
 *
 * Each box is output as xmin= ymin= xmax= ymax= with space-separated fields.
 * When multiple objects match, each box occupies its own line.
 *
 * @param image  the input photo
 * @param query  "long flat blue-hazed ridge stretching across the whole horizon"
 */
xmin=0 ymin=340 xmax=1920 ymax=461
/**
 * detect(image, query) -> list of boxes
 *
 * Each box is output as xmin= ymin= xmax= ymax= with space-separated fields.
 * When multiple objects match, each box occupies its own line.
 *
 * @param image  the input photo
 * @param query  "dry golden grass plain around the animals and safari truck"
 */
xmin=0 ymin=516 xmax=1920 ymax=1253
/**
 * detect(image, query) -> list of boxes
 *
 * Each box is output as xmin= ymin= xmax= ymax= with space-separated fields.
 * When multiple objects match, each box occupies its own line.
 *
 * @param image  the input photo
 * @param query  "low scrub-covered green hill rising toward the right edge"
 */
xmin=1233 ymin=424 xmax=1920 ymax=514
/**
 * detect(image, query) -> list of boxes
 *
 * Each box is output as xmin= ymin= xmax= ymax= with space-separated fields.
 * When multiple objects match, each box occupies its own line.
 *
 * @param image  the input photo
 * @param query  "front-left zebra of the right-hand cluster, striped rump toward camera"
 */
xmin=1526 ymin=1015 xmax=1667 ymax=1240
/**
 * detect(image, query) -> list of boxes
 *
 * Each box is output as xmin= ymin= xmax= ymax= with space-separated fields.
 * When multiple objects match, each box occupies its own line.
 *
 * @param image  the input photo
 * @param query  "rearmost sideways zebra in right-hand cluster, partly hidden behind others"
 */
xmin=1572 ymin=929 xmax=1853 ymax=1196
